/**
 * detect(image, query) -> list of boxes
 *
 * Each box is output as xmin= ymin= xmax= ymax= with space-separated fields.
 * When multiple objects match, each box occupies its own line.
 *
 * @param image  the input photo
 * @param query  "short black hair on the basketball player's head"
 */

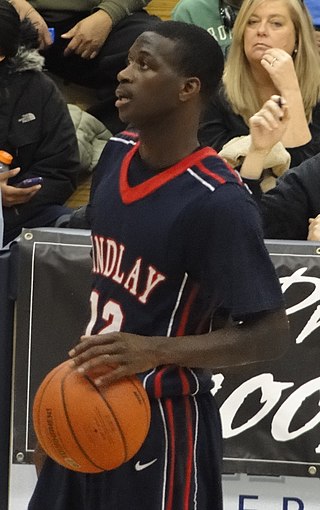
xmin=149 ymin=20 xmax=224 ymax=102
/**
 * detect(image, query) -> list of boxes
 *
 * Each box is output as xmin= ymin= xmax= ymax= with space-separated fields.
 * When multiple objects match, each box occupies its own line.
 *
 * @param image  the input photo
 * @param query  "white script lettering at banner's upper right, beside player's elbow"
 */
xmin=279 ymin=267 xmax=320 ymax=344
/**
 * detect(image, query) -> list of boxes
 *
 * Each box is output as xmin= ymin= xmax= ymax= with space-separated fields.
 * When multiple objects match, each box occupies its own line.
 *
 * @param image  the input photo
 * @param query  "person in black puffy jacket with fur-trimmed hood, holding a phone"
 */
xmin=0 ymin=0 xmax=79 ymax=245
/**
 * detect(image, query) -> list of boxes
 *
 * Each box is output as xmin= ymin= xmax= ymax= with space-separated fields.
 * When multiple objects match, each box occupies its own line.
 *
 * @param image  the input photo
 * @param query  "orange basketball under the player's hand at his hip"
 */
xmin=33 ymin=361 xmax=150 ymax=473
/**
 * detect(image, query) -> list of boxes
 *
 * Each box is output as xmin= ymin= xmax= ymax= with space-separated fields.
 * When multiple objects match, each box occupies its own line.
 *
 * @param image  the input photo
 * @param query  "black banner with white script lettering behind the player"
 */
xmin=13 ymin=229 xmax=320 ymax=477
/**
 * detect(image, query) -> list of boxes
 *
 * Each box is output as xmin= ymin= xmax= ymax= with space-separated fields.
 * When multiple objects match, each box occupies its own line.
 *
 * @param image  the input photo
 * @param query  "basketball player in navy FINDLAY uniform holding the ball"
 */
xmin=29 ymin=21 xmax=288 ymax=510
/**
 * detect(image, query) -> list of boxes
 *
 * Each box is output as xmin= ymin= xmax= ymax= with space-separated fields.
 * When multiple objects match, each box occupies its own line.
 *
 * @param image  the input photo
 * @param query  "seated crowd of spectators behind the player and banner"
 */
xmin=0 ymin=0 xmax=320 ymax=246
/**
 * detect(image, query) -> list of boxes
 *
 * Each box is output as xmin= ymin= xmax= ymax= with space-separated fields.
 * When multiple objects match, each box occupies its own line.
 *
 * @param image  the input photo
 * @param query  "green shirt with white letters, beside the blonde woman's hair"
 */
xmin=171 ymin=0 xmax=232 ymax=54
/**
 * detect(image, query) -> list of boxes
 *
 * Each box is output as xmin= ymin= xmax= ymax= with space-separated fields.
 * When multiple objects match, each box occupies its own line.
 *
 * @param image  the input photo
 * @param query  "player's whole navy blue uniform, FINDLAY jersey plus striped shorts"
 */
xmin=28 ymin=134 xmax=283 ymax=510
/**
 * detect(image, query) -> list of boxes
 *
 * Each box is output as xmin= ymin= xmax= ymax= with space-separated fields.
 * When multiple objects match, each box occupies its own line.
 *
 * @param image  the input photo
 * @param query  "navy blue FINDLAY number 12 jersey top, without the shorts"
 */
xmin=86 ymin=133 xmax=283 ymax=397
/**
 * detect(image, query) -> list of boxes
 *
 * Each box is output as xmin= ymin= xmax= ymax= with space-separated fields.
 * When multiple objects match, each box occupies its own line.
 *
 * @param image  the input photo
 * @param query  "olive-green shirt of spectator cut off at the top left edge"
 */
xmin=29 ymin=0 xmax=150 ymax=25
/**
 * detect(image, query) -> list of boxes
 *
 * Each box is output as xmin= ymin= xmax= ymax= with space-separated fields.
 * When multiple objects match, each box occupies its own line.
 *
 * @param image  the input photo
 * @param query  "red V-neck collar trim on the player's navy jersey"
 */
xmin=120 ymin=142 xmax=217 ymax=204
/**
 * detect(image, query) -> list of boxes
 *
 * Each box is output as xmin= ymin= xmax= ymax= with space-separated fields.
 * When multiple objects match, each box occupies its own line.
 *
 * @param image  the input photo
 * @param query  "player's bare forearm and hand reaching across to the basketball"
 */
xmin=69 ymin=309 xmax=289 ymax=384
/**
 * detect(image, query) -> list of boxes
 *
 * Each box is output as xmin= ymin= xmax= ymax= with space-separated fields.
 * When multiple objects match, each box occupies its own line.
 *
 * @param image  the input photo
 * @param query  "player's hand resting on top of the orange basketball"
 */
xmin=69 ymin=332 xmax=157 ymax=385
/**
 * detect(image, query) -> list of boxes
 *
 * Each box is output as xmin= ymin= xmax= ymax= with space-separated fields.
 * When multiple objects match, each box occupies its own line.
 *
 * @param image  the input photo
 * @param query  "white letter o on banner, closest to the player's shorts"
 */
xmin=220 ymin=374 xmax=294 ymax=439
